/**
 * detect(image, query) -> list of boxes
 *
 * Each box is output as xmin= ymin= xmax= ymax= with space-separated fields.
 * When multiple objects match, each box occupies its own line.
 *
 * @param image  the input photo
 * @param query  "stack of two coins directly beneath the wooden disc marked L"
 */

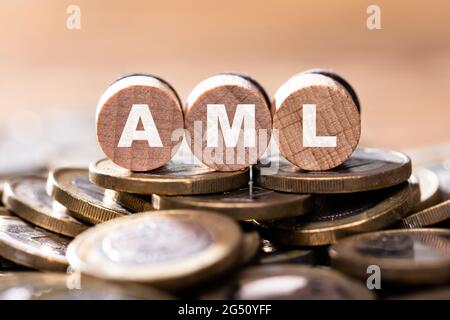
xmin=254 ymin=149 xmax=419 ymax=246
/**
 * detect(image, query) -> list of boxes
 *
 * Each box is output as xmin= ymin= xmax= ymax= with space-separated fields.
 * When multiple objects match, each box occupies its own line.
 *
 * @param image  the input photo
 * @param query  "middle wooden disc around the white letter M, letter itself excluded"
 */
xmin=184 ymin=74 xmax=272 ymax=171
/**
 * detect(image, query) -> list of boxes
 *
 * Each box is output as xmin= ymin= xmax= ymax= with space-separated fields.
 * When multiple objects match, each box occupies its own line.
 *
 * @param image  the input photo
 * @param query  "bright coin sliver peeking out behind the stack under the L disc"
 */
xmin=413 ymin=167 xmax=441 ymax=212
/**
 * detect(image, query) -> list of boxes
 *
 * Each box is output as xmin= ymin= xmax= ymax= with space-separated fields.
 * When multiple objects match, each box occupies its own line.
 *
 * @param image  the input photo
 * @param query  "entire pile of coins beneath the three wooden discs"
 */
xmin=0 ymin=141 xmax=450 ymax=299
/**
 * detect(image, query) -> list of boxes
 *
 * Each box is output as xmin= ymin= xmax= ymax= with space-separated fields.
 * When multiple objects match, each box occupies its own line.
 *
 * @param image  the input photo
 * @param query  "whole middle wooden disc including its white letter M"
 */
xmin=185 ymin=73 xmax=272 ymax=171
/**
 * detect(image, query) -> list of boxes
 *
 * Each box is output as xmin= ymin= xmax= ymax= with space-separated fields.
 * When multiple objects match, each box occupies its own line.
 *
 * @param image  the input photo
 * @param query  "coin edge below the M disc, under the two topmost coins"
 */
xmin=152 ymin=187 xmax=312 ymax=221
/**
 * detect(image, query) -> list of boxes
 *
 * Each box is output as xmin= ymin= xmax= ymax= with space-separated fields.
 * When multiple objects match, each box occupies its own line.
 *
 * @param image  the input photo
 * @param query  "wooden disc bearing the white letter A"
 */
xmin=96 ymin=75 xmax=184 ymax=171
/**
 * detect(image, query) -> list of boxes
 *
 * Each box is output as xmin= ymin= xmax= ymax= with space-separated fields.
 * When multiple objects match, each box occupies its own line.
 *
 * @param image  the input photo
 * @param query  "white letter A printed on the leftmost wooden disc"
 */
xmin=117 ymin=104 xmax=163 ymax=147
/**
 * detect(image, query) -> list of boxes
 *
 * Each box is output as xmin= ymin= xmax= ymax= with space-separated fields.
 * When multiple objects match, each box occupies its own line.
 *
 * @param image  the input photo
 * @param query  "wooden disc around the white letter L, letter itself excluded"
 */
xmin=272 ymin=73 xmax=361 ymax=171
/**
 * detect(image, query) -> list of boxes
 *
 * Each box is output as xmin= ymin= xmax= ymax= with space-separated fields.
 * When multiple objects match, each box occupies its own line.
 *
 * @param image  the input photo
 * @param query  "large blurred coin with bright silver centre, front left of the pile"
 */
xmin=67 ymin=210 xmax=242 ymax=289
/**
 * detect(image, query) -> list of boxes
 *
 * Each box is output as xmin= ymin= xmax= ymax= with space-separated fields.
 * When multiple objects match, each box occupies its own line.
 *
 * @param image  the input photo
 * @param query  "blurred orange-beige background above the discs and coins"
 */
xmin=0 ymin=0 xmax=450 ymax=149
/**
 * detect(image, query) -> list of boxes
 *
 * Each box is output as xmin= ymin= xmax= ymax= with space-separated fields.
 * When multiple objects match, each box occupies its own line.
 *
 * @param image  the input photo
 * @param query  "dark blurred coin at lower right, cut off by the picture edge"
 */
xmin=329 ymin=229 xmax=450 ymax=285
